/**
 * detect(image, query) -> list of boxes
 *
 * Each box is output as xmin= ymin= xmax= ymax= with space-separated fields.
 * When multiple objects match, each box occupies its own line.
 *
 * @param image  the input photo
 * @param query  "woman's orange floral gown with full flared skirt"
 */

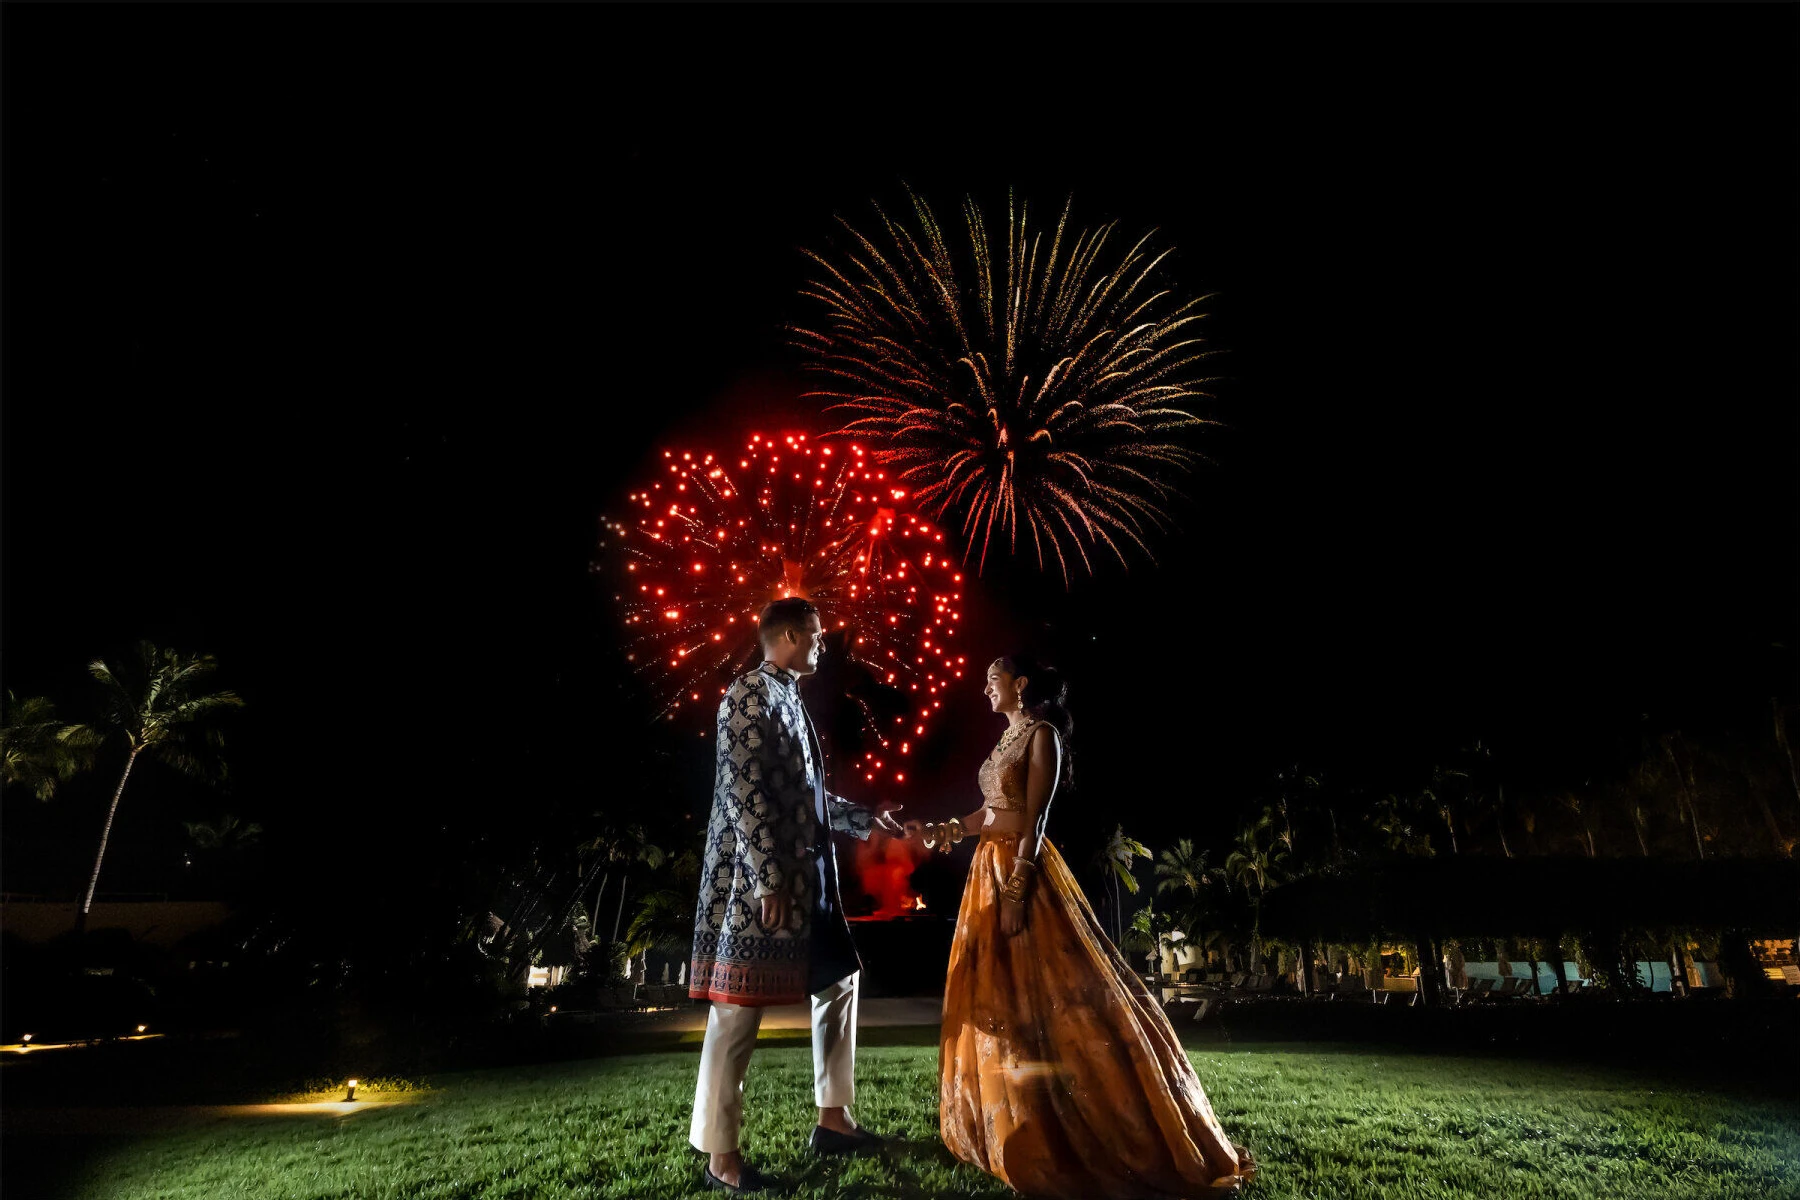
xmin=938 ymin=729 xmax=1255 ymax=1200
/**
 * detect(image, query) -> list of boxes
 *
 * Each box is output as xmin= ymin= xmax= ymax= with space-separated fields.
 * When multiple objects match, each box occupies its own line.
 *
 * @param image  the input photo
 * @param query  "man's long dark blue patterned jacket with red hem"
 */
xmin=688 ymin=662 xmax=875 ymax=1006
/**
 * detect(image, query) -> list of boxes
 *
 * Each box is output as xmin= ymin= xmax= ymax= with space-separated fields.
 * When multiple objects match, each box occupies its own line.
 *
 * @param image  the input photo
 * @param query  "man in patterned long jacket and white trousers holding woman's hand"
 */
xmin=688 ymin=599 xmax=904 ymax=1195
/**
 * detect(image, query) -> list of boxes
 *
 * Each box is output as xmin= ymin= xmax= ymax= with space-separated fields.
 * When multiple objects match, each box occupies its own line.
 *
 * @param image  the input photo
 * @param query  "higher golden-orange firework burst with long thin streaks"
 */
xmin=790 ymin=193 xmax=1213 ymax=585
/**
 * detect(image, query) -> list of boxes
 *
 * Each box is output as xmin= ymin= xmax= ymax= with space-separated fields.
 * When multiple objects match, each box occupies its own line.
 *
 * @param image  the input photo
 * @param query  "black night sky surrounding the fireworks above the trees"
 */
xmin=0 ymin=5 xmax=1796 ymax=891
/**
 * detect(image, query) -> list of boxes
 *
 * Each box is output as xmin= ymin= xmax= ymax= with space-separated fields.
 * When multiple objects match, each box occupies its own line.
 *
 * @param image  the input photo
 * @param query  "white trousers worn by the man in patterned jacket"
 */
xmin=688 ymin=972 xmax=860 ymax=1155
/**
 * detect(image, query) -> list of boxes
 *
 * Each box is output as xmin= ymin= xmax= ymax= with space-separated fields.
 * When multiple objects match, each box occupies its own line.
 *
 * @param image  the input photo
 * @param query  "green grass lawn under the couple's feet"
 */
xmin=40 ymin=1031 xmax=1800 ymax=1200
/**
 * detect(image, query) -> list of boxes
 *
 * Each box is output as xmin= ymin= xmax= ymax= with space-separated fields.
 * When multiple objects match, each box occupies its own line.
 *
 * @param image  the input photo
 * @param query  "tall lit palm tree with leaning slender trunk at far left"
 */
xmin=76 ymin=642 xmax=243 ymax=932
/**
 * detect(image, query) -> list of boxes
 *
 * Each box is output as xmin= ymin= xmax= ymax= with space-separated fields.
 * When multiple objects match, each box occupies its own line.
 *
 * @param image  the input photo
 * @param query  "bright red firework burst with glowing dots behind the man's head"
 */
xmin=607 ymin=434 xmax=967 ymax=798
